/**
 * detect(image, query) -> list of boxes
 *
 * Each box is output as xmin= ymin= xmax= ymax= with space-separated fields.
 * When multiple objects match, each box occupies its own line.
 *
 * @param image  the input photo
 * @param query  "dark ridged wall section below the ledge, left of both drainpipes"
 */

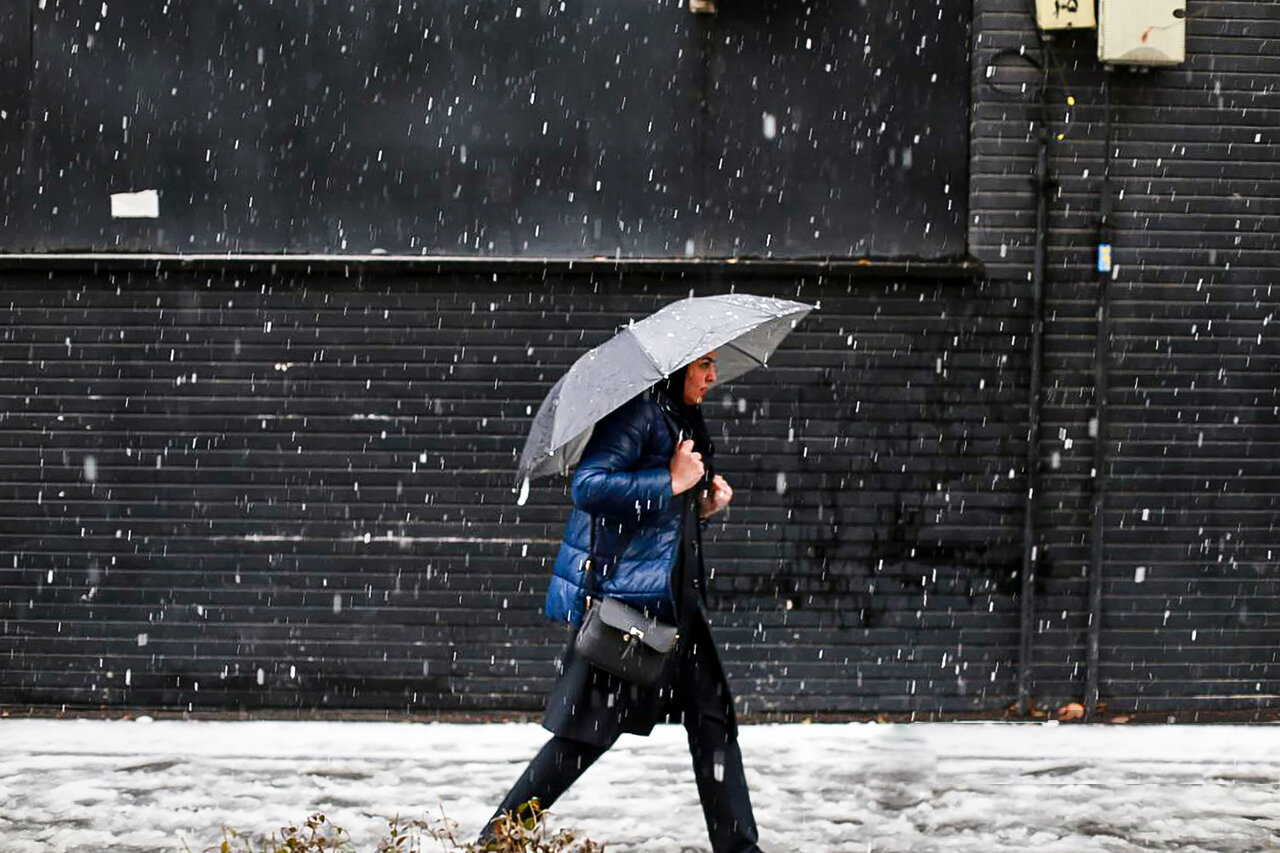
xmin=0 ymin=268 xmax=1025 ymax=713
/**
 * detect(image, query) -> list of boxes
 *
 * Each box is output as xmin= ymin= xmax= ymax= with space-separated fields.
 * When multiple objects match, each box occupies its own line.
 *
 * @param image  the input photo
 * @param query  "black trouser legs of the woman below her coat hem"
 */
xmin=480 ymin=713 xmax=760 ymax=853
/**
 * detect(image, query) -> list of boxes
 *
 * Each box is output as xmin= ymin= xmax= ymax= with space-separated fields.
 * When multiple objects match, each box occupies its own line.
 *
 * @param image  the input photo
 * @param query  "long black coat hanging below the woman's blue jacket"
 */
xmin=543 ymin=489 xmax=737 ymax=747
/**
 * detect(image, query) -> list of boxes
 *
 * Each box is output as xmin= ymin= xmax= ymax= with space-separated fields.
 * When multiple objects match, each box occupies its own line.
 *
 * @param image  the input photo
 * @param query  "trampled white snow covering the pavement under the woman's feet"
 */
xmin=0 ymin=720 xmax=1280 ymax=853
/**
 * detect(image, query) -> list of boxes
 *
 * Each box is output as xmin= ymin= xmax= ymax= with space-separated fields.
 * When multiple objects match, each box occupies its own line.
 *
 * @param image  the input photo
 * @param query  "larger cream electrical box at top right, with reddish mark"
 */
xmin=1098 ymin=0 xmax=1187 ymax=65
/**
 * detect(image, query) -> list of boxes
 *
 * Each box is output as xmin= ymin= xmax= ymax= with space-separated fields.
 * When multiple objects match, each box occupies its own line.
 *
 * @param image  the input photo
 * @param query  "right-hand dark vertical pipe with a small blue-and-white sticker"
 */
xmin=1084 ymin=70 xmax=1111 ymax=720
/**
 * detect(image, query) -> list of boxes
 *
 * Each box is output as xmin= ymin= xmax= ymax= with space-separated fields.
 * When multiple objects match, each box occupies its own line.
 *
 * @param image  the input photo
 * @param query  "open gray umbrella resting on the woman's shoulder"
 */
xmin=516 ymin=293 xmax=814 ymax=497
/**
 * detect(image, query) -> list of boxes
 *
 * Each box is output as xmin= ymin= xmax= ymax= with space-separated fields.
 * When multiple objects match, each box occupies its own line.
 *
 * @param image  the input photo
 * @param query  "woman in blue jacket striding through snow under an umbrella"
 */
xmin=481 ymin=352 xmax=760 ymax=853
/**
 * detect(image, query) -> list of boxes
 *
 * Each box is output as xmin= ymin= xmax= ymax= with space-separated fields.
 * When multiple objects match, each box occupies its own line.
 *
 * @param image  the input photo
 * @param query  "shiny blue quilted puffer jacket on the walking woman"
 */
xmin=547 ymin=393 xmax=685 ymax=625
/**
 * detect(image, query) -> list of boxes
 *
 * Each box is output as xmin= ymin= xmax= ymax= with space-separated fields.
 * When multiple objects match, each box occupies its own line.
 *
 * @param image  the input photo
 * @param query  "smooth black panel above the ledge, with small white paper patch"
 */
xmin=0 ymin=0 xmax=969 ymax=259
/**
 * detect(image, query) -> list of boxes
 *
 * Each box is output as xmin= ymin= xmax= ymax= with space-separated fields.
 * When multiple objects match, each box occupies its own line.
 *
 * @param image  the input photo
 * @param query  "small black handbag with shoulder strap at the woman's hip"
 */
xmin=573 ymin=517 xmax=680 ymax=686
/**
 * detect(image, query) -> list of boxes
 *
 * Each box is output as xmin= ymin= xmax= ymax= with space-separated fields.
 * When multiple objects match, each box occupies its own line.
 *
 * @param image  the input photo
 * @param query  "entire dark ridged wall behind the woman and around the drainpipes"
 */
xmin=0 ymin=0 xmax=1280 ymax=712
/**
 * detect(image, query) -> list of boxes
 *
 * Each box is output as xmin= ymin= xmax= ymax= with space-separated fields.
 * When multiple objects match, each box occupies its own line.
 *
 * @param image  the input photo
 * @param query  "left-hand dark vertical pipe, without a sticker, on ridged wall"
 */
xmin=1018 ymin=56 xmax=1052 ymax=716
